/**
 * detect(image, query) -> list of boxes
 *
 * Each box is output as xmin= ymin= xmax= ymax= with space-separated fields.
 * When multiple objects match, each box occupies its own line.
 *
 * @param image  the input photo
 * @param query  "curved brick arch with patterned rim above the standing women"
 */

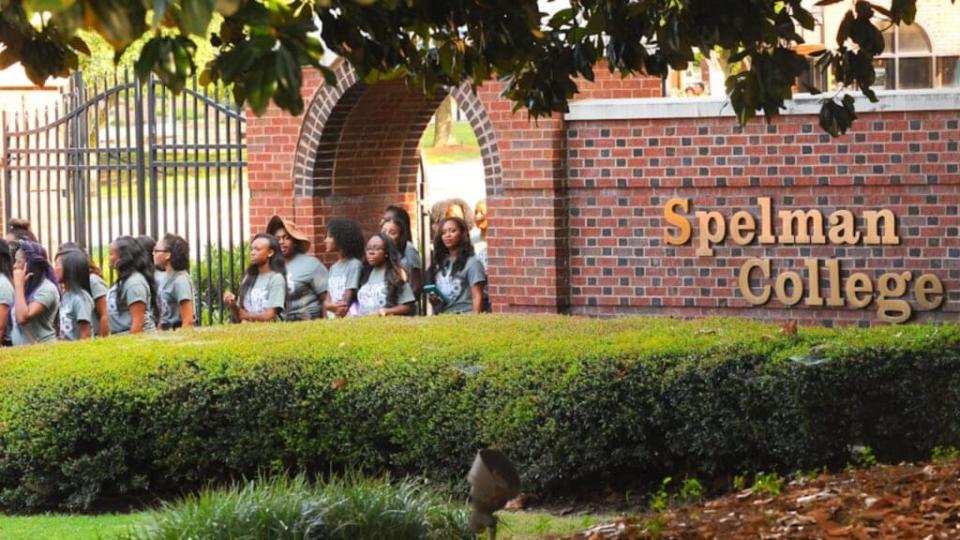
xmin=293 ymin=61 xmax=503 ymax=238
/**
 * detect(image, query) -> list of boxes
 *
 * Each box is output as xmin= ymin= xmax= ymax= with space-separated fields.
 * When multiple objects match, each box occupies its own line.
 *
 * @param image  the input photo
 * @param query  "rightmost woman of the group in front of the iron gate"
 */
xmin=153 ymin=234 xmax=196 ymax=330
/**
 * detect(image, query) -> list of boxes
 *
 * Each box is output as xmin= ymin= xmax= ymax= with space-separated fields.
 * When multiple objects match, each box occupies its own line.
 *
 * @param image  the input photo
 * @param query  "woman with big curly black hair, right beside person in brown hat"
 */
xmin=323 ymin=218 xmax=364 ymax=319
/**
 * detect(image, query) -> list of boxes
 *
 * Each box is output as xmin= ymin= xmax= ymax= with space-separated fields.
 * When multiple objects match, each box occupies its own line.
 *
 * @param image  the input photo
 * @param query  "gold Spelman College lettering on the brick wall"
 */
xmin=663 ymin=197 xmax=945 ymax=323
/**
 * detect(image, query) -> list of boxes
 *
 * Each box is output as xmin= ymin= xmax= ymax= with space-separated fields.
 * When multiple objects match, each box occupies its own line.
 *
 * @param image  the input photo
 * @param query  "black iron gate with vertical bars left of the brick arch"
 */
xmin=0 ymin=72 xmax=249 ymax=324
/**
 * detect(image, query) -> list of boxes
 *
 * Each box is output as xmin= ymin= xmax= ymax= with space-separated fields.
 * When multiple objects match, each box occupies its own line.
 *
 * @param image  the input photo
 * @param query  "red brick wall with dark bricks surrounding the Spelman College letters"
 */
xmin=567 ymin=112 xmax=960 ymax=324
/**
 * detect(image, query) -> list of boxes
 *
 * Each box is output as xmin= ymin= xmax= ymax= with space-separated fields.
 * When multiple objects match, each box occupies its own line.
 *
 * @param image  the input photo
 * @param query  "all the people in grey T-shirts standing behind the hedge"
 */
xmin=0 ymin=202 xmax=489 ymax=345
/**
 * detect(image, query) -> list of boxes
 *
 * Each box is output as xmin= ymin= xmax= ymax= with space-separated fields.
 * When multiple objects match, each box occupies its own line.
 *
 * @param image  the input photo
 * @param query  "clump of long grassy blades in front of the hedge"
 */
xmin=122 ymin=476 xmax=475 ymax=540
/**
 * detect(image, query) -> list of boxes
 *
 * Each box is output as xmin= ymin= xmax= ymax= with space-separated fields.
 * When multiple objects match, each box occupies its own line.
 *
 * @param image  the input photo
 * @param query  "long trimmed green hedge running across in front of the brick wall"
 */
xmin=0 ymin=315 xmax=960 ymax=511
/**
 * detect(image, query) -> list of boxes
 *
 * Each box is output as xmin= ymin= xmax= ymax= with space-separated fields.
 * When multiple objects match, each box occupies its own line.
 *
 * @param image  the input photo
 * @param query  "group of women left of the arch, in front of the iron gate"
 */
xmin=0 ymin=220 xmax=195 ymax=345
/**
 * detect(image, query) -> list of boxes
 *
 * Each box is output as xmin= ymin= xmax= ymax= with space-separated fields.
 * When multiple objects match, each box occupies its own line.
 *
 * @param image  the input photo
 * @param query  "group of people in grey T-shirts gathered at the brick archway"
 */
xmin=223 ymin=206 xmax=489 ymax=322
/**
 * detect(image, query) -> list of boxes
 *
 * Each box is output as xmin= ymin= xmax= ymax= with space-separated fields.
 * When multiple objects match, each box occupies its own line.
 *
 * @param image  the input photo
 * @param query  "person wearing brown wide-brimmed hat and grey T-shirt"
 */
xmin=267 ymin=216 xmax=327 ymax=321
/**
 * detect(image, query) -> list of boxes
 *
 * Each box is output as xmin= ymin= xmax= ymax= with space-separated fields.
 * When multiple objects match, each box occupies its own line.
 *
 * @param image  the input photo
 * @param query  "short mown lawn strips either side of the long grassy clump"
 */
xmin=0 ymin=512 xmax=616 ymax=540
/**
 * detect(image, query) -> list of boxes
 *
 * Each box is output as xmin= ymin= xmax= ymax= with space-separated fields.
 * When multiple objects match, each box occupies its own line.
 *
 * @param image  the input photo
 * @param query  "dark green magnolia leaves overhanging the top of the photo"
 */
xmin=0 ymin=0 xmax=944 ymax=136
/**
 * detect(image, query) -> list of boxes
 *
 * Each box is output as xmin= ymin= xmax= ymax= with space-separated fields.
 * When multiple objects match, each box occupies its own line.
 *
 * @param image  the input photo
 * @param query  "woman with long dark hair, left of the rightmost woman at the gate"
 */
xmin=107 ymin=236 xmax=159 ymax=334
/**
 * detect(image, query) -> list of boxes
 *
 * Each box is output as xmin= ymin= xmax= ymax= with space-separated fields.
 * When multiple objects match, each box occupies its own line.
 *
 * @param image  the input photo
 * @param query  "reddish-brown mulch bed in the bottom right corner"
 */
xmin=564 ymin=460 xmax=960 ymax=540
